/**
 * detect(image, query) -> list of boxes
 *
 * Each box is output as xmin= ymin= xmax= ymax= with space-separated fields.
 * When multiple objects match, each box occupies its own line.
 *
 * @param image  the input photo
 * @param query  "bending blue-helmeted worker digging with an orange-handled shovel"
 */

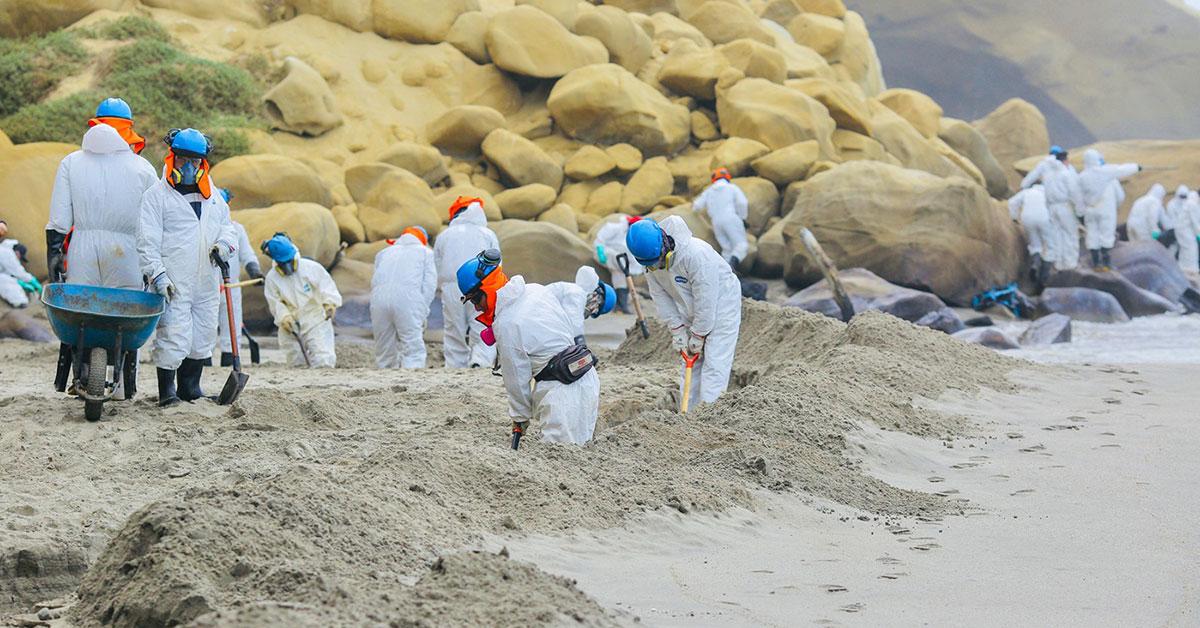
xmin=626 ymin=216 xmax=742 ymax=405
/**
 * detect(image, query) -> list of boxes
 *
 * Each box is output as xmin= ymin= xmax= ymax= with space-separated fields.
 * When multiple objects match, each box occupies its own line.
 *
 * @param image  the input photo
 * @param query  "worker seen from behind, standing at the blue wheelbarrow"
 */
xmin=46 ymin=98 xmax=158 ymax=399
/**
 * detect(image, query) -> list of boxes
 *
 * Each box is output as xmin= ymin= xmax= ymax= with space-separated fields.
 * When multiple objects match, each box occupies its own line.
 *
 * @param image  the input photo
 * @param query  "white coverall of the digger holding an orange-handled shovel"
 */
xmin=646 ymin=216 xmax=742 ymax=406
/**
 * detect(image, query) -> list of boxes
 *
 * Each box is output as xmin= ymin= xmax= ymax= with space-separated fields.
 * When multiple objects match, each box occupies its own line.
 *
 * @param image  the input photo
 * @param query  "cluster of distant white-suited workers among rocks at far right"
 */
xmin=1008 ymin=145 xmax=1200 ymax=285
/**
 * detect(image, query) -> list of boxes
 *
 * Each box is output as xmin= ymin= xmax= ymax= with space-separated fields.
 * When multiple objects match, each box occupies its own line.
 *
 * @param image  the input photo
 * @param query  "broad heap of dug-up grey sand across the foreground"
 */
xmin=0 ymin=303 xmax=1016 ymax=626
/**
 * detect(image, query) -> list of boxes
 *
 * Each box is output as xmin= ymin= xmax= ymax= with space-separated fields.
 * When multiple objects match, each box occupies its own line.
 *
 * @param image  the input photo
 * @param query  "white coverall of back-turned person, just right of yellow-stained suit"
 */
xmin=371 ymin=233 xmax=438 ymax=369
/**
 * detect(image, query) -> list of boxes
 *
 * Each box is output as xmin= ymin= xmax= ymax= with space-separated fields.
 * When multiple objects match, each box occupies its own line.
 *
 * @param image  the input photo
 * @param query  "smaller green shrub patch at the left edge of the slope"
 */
xmin=0 ymin=31 xmax=88 ymax=116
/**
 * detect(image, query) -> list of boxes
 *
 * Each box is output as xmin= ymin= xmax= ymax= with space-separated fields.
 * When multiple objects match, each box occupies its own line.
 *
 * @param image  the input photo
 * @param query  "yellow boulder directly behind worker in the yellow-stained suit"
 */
xmin=232 ymin=203 xmax=342 ymax=269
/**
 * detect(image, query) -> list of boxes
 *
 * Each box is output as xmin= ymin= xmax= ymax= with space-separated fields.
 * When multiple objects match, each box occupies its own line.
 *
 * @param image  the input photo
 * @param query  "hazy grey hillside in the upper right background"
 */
xmin=848 ymin=0 xmax=1200 ymax=145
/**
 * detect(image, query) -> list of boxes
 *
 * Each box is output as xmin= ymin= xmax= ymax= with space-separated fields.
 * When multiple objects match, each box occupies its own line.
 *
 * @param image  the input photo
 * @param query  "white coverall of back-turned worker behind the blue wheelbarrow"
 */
xmin=46 ymin=124 xmax=157 ymax=286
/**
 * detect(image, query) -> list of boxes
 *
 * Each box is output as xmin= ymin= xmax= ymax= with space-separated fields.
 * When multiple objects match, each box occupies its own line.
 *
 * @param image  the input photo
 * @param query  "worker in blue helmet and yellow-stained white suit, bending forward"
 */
xmin=262 ymin=233 xmax=342 ymax=369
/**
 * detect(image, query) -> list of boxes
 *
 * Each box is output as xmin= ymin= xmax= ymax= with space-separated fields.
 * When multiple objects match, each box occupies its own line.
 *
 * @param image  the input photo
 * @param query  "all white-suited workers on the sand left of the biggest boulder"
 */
xmin=14 ymin=98 xmax=748 ymax=443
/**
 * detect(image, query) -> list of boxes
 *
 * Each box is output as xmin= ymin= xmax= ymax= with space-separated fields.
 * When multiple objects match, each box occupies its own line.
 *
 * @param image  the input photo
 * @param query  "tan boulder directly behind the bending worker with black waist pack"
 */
xmin=491 ymin=220 xmax=607 ymax=285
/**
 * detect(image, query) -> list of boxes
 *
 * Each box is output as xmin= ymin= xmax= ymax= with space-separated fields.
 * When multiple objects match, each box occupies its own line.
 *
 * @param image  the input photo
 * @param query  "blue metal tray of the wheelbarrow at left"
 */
xmin=42 ymin=283 xmax=166 ymax=364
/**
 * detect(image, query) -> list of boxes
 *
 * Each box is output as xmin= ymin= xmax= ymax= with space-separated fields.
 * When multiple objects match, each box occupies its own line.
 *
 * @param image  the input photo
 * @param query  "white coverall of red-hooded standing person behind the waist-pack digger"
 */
xmin=433 ymin=203 xmax=500 ymax=369
